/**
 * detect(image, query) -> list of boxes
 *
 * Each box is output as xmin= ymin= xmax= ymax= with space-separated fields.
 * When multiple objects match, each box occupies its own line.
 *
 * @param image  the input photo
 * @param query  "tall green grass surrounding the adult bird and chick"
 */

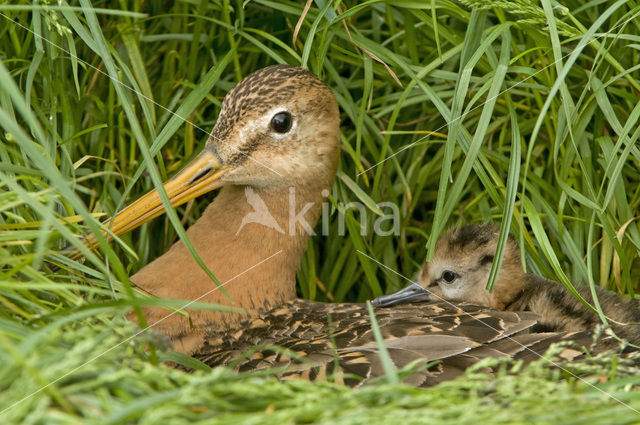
xmin=0 ymin=0 xmax=640 ymax=424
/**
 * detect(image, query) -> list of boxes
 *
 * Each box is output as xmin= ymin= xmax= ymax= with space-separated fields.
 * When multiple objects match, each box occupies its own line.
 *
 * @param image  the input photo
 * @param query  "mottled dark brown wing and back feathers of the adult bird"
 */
xmin=195 ymin=300 xmax=616 ymax=386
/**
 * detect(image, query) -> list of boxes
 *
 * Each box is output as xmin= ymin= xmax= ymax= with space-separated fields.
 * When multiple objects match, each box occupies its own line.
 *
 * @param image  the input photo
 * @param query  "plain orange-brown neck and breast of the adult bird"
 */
xmin=131 ymin=183 xmax=330 ymax=353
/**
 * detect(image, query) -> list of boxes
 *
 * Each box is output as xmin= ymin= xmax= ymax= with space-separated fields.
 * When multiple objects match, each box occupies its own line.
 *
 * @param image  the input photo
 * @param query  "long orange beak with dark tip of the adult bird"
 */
xmin=85 ymin=148 xmax=230 ymax=247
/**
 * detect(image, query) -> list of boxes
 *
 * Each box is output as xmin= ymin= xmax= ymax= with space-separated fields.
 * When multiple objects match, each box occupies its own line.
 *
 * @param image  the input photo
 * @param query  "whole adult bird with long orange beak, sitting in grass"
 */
xmin=86 ymin=65 xmax=616 ymax=385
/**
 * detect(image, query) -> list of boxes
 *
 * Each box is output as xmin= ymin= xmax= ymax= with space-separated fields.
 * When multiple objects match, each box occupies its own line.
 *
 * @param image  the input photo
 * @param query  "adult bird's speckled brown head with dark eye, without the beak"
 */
xmin=209 ymin=65 xmax=340 ymax=187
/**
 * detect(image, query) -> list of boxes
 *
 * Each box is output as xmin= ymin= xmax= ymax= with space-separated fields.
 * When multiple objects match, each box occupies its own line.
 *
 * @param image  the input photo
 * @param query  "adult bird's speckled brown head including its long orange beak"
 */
xmin=97 ymin=65 xmax=340 ymax=238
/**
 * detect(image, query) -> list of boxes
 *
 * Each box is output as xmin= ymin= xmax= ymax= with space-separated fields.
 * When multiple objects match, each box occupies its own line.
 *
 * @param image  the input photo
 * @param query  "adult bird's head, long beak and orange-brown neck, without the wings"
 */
xmin=99 ymin=65 xmax=340 ymax=353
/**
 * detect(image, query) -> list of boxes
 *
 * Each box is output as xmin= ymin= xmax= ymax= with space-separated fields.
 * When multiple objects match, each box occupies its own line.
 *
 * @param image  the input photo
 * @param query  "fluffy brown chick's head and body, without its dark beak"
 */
xmin=419 ymin=224 xmax=640 ymax=344
